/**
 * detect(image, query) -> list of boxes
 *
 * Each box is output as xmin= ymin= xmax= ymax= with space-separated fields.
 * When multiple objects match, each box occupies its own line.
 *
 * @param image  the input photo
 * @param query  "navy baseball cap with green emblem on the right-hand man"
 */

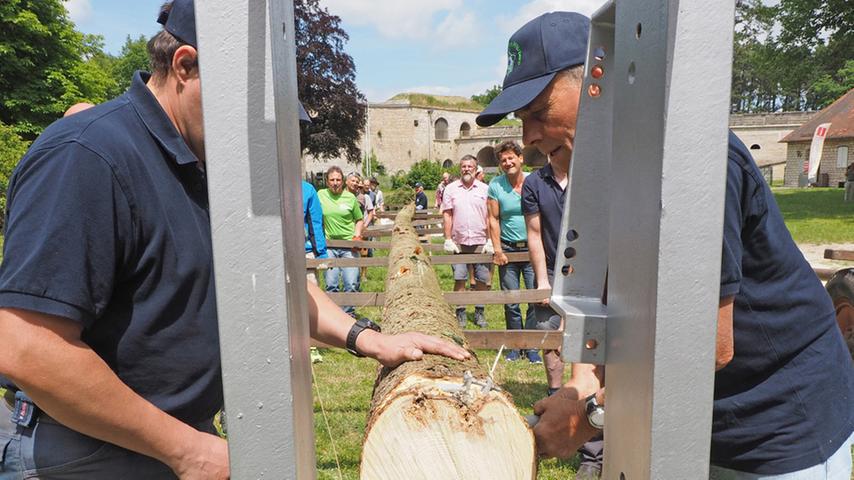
xmin=476 ymin=12 xmax=590 ymax=127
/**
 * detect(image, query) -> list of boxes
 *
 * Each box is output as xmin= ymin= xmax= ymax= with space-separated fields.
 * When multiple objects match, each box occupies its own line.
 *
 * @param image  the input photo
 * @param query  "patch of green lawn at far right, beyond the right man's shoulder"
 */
xmin=774 ymin=188 xmax=854 ymax=244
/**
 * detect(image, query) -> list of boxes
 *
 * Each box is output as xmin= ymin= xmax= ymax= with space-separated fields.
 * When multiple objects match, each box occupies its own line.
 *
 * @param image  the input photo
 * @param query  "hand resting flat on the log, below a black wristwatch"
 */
xmin=356 ymin=330 xmax=471 ymax=368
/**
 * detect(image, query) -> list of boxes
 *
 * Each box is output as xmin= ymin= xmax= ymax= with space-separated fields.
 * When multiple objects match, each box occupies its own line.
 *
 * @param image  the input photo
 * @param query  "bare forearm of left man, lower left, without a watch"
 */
xmin=0 ymin=309 xmax=206 ymax=468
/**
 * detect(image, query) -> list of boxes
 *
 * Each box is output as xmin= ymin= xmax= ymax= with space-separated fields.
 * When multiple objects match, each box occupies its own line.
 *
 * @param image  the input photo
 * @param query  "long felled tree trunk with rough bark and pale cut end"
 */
xmin=361 ymin=205 xmax=536 ymax=480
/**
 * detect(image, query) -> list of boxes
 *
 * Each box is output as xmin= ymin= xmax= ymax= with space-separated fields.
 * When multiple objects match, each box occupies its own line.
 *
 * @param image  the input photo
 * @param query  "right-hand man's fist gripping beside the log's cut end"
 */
xmin=534 ymin=383 xmax=599 ymax=458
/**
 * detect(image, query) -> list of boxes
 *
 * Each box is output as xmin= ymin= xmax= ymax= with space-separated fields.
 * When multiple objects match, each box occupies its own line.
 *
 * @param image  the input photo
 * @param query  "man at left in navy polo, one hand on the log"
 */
xmin=0 ymin=0 xmax=468 ymax=480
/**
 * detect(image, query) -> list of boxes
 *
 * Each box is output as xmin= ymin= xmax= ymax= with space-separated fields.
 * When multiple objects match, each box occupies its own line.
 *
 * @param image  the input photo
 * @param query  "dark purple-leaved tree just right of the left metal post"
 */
xmin=294 ymin=0 xmax=367 ymax=162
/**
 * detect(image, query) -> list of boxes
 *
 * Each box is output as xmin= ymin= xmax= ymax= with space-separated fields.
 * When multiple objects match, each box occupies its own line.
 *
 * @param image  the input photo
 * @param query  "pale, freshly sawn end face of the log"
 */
xmin=361 ymin=376 xmax=536 ymax=480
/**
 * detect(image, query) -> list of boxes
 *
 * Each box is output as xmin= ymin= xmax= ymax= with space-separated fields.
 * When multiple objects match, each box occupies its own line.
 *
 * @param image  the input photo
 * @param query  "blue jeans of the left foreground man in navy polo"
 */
xmin=0 ymin=398 xmax=215 ymax=480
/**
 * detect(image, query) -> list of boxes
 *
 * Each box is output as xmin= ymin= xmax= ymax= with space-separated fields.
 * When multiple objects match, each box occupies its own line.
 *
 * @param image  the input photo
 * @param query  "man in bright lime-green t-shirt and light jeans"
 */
xmin=317 ymin=166 xmax=363 ymax=317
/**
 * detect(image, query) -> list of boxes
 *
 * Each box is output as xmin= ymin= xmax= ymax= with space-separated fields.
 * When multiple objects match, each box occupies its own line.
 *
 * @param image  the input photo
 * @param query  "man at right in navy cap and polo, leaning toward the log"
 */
xmin=478 ymin=8 xmax=854 ymax=480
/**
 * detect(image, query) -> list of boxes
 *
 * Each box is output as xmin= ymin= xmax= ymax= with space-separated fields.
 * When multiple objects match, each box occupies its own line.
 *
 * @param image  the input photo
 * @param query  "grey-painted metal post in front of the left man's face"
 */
xmin=196 ymin=0 xmax=315 ymax=479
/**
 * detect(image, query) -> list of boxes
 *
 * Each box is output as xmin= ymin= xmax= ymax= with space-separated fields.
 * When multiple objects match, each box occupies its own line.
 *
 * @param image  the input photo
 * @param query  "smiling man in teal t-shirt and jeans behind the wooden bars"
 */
xmin=486 ymin=141 xmax=543 ymax=363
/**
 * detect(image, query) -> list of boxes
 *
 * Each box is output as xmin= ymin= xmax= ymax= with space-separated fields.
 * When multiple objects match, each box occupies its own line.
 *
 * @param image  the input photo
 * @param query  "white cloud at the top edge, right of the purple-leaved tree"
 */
xmin=321 ymin=0 xmax=463 ymax=39
